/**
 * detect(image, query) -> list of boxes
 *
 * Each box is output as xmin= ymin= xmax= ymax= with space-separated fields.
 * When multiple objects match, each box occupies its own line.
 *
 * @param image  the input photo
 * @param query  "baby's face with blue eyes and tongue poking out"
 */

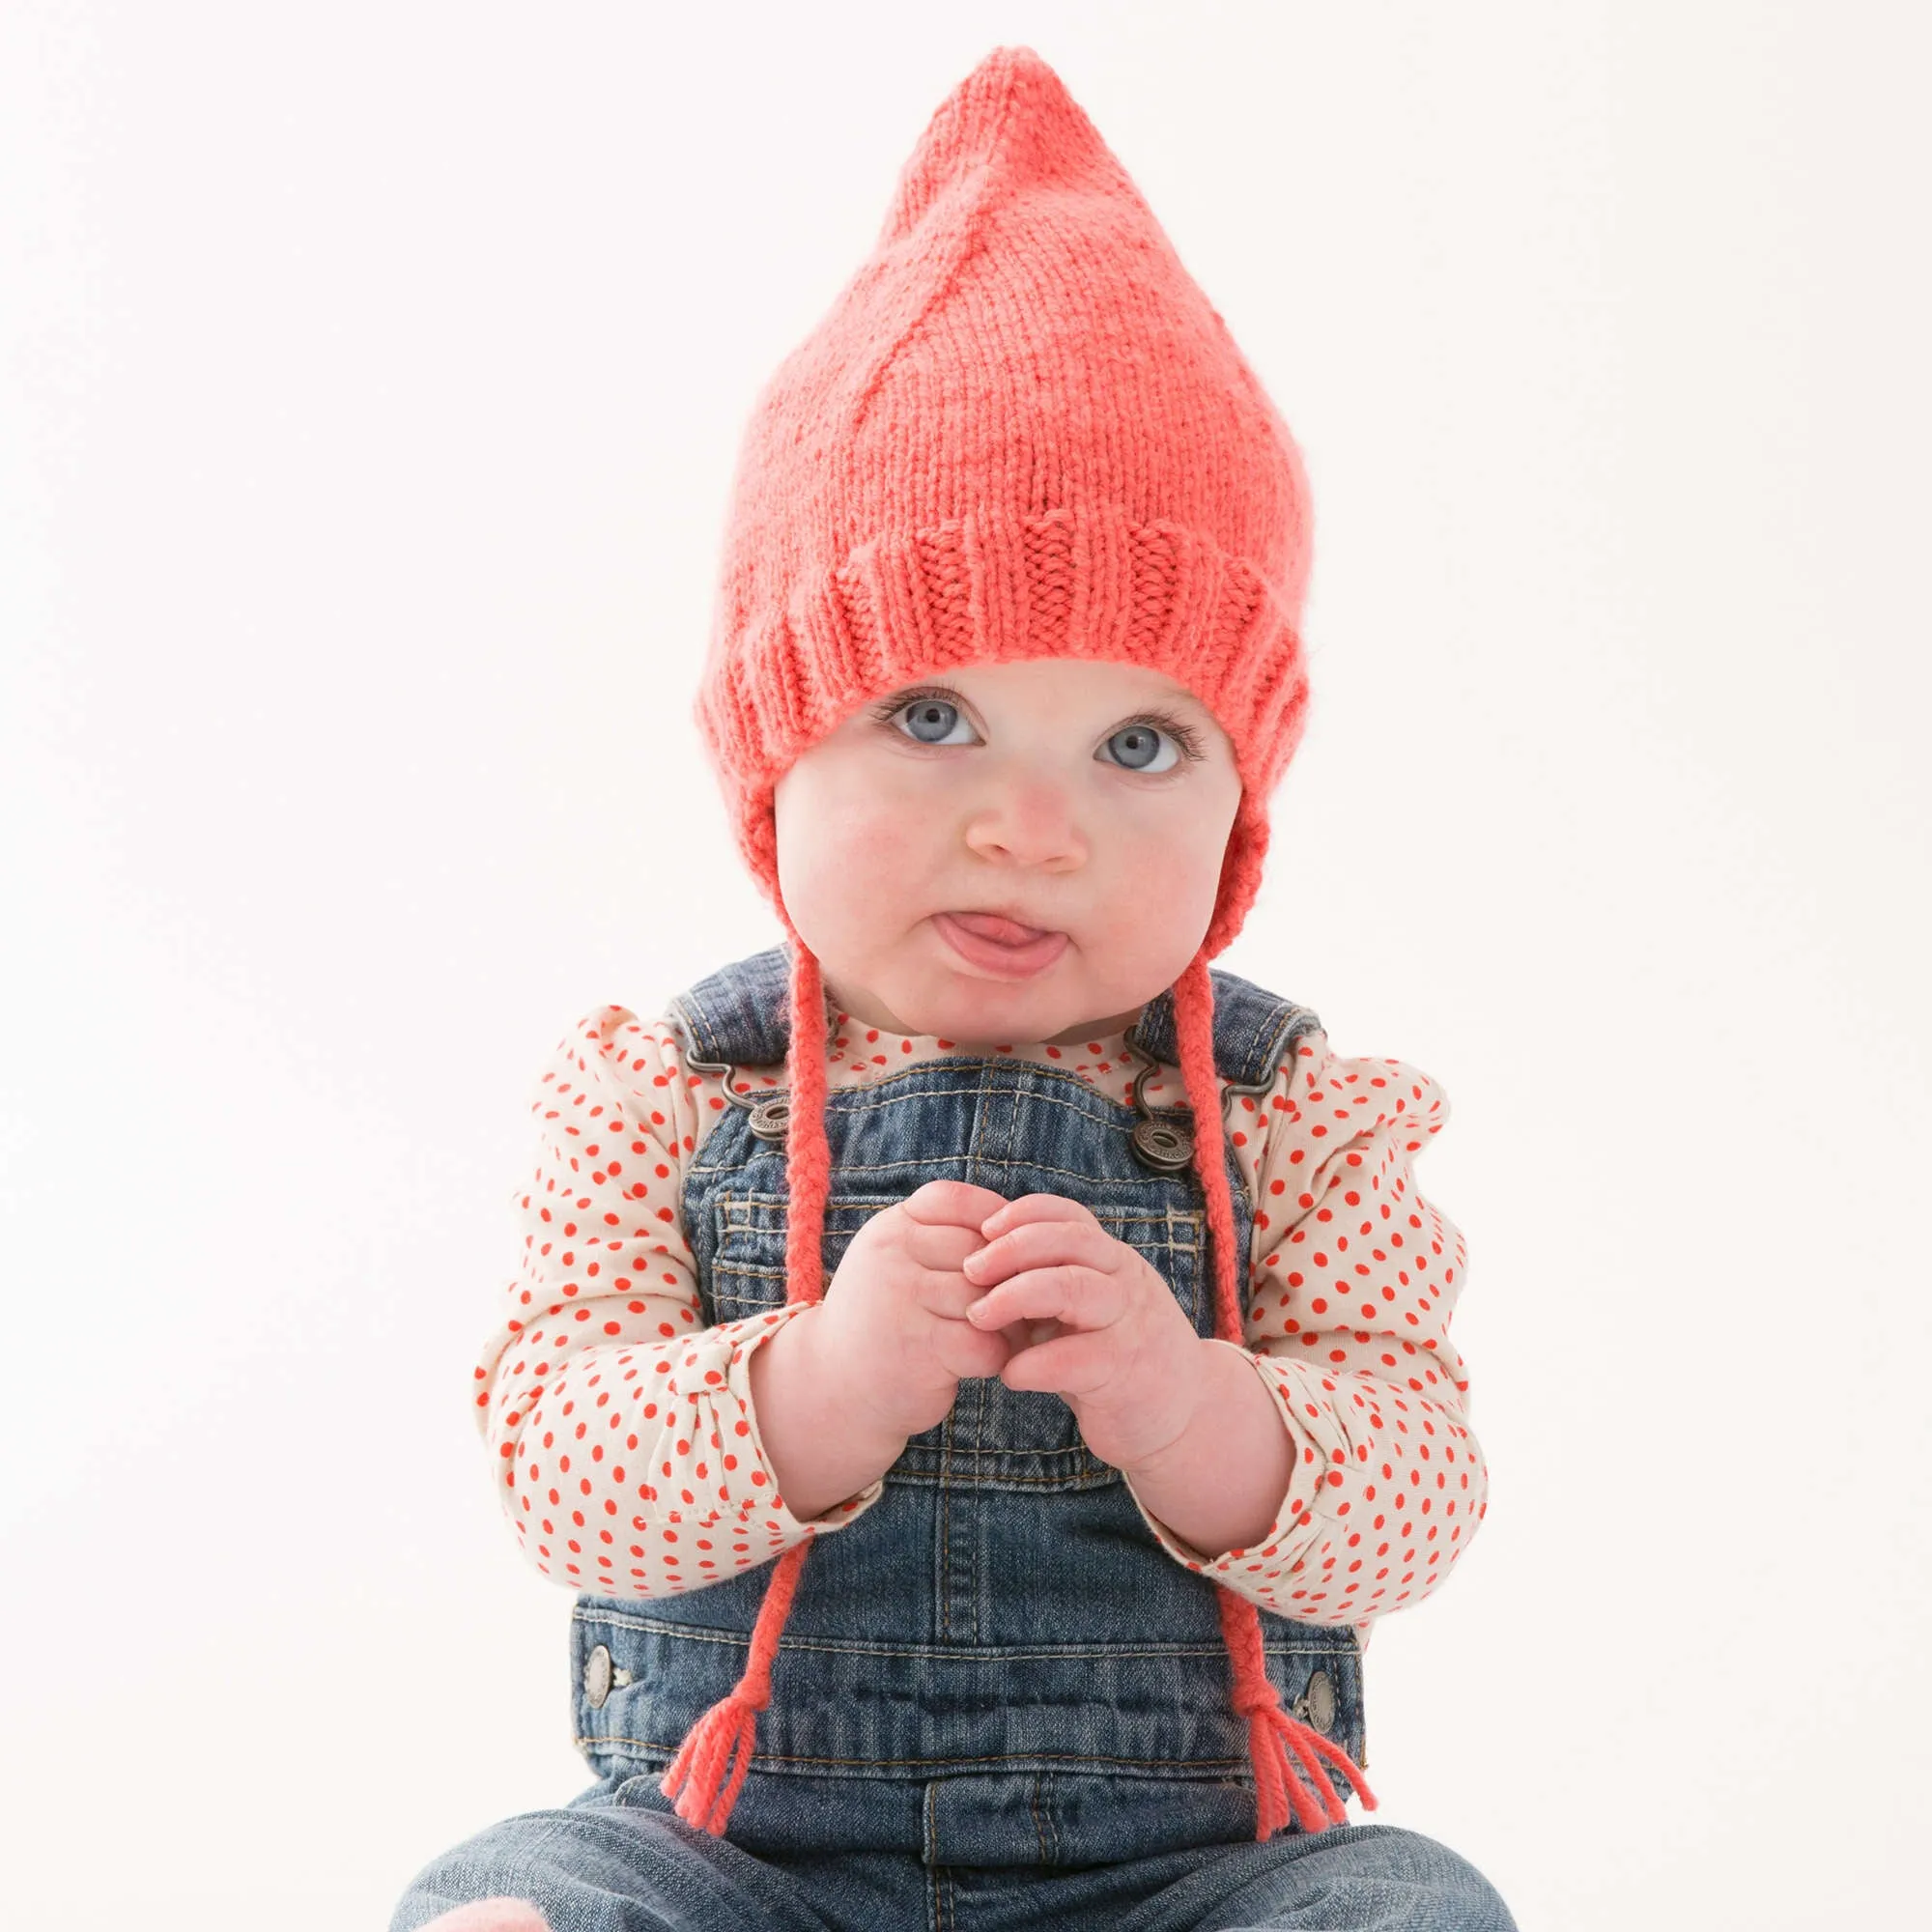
xmin=775 ymin=657 xmax=1240 ymax=1047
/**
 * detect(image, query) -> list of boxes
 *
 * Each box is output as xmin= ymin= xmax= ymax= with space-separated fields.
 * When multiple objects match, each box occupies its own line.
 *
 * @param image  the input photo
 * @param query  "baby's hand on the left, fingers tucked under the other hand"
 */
xmin=813 ymin=1180 xmax=1024 ymax=1441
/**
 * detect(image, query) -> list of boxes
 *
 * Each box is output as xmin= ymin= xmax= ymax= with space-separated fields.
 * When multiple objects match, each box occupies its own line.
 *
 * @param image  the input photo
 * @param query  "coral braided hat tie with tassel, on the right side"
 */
xmin=1175 ymin=945 xmax=1379 ymax=1839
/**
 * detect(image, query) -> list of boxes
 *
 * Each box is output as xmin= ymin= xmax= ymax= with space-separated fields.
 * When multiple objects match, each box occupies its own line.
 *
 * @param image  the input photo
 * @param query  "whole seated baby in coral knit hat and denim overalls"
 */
xmin=390 ymin=46 xmax=1513 ymax=1932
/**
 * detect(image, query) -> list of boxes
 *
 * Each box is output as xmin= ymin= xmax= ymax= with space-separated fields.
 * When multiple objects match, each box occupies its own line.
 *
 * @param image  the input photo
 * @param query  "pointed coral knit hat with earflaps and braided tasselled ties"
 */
xmin=661 ymin=46 xmax=1376 ymax=1839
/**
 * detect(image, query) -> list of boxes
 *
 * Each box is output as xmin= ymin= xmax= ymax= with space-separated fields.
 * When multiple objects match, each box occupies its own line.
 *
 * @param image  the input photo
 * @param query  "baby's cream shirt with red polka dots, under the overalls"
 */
xmin=473 ymin=1007 xmax=1488 ymax=1646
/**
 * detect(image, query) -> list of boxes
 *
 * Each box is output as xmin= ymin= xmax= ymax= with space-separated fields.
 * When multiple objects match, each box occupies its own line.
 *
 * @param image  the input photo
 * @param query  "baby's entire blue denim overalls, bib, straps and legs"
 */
xmin=390 ymin=947 xmax=1515 ymax=1932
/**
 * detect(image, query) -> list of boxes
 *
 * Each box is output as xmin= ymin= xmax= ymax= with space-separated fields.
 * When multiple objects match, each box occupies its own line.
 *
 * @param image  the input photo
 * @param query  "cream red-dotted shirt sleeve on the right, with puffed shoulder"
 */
xmin=1142 ymin=1032 xmax=1488 ymax=1638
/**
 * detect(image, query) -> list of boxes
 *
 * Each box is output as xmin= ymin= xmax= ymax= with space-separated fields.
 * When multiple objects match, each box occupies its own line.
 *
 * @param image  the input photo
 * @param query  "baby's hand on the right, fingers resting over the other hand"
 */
xmin=962 ymin=1190 xmax=1208 ymax=1468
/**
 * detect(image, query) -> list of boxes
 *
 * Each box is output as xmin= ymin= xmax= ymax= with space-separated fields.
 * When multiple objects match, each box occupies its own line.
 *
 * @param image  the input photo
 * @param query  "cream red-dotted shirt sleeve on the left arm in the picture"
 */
xmin=473 ymin=1007 xmax=885 ymax=1598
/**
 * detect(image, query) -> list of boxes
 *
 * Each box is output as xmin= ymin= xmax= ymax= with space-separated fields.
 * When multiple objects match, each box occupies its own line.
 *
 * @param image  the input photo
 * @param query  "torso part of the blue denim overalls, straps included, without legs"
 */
xmin=570 ymin=947 xmax=1366 ymax=1866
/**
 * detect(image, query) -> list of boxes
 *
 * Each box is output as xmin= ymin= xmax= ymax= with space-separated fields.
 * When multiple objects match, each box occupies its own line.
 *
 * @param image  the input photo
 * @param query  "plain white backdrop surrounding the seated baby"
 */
xmin=0 ymin=0 xmax=1932 ymax=1932
